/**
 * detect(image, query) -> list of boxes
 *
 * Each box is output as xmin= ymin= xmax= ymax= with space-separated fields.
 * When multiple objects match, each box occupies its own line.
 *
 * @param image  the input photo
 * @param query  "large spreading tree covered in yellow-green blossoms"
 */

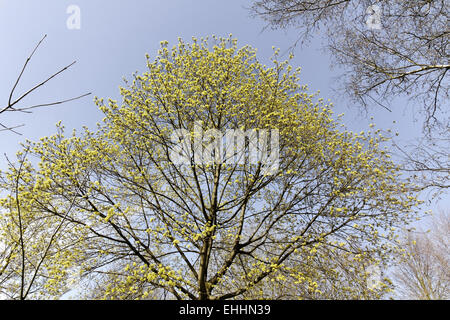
xmin=2 ymin=37 xmax=418 ymax=300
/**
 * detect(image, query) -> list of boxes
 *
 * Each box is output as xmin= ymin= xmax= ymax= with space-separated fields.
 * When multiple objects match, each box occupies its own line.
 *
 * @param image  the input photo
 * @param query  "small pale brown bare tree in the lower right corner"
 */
xmin=394 ymin=211 xmax=450 ymax=300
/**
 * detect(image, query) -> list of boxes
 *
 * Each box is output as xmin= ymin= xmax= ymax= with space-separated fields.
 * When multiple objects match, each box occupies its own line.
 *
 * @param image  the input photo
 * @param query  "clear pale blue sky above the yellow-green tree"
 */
xmin=0 ymin=0 xmax=450 ymax=212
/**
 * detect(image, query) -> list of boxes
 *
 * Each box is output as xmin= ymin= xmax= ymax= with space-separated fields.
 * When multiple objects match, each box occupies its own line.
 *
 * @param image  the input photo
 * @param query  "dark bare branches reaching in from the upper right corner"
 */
xmin=252 ymin=0 xmax=450 ymax=192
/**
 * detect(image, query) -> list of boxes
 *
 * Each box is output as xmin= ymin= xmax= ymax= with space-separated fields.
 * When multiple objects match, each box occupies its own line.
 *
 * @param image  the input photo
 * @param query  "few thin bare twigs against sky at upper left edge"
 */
xmin=0 ymin=35 xmax=91 ymax=134
